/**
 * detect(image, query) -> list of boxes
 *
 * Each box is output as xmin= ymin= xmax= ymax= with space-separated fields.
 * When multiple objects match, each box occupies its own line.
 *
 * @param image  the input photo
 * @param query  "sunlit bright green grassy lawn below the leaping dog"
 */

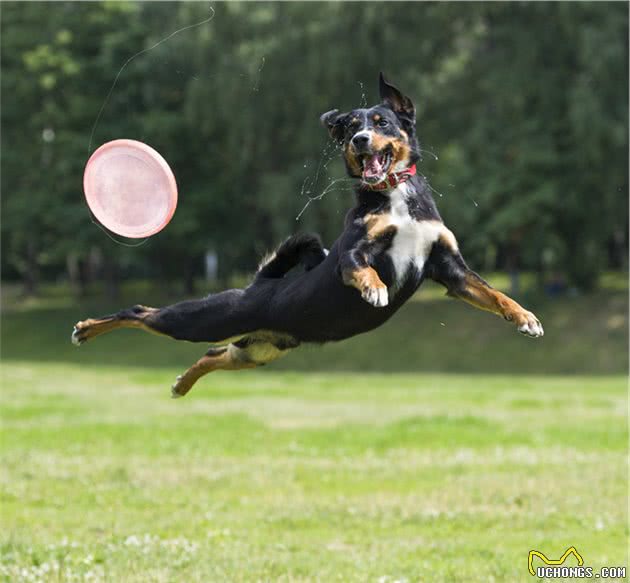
xmin=0 ymin=364 xmax=628 ymax=583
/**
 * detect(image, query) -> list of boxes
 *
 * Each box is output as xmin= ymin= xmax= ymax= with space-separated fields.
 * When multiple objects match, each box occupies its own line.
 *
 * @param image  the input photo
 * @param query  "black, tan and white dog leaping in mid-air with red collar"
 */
xmin=72 ymin=75 xmax=543 ymax=397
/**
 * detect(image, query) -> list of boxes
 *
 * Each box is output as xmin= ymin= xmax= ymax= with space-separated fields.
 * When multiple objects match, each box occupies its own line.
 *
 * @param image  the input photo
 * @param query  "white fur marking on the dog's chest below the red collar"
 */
xmin=387 ymin=183 xmax=446 ymax=287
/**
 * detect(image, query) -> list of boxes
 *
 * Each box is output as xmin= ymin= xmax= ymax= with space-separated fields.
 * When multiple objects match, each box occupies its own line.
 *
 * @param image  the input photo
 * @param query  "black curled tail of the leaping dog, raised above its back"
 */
xmin=256 ymin=233 xmax=328 ymax=279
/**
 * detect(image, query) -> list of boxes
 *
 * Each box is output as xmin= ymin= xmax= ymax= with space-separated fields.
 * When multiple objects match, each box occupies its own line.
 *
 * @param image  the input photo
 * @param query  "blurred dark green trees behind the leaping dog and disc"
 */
xmin=1 ymin=2 xmax=628 ymax=295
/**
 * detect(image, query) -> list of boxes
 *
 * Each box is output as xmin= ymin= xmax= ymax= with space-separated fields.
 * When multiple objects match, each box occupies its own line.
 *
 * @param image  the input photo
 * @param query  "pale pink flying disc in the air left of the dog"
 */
xmin=83 ymin=140 xmax=177 ymax=238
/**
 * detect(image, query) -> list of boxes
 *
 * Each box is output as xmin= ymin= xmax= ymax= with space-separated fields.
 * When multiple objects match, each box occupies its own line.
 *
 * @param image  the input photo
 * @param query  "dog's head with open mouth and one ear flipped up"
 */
xmin=321 ymin=73 xmax=420 ymax=184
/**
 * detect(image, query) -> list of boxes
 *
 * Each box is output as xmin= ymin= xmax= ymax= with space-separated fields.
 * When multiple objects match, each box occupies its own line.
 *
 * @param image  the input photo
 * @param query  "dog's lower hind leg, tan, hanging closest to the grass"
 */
xmin=171 ymin=338 xmax=297 ymax=399
